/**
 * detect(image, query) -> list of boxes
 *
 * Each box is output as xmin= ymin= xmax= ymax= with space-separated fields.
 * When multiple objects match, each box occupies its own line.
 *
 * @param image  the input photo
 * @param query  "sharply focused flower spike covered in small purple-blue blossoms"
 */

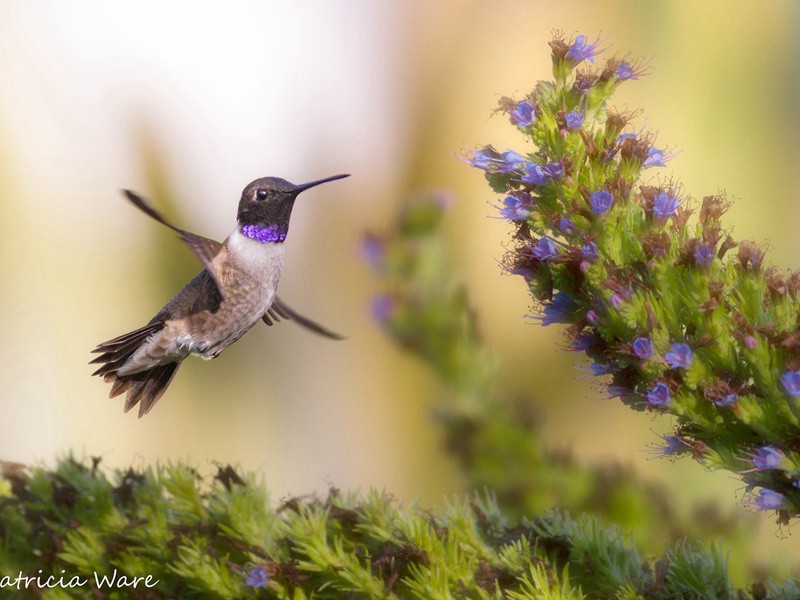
xmin=467 ymin=36 xmax=800 ymax=519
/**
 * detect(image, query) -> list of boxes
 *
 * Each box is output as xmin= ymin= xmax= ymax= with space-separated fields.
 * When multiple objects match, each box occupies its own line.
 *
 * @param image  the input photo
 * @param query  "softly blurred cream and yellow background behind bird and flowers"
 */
xmin=0 ymin=0 xmax=800 ymax=580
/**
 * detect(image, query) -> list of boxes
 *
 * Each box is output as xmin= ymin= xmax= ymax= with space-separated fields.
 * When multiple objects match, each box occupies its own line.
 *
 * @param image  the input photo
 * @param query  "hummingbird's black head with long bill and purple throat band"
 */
xmin=237 ymin=175 xmax=349 ymax=242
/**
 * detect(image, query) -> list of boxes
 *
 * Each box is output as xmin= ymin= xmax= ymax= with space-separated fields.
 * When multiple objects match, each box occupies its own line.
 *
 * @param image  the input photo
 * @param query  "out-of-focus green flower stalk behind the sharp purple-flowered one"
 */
xmin=363 ymin=194 xmax=747 ymax=555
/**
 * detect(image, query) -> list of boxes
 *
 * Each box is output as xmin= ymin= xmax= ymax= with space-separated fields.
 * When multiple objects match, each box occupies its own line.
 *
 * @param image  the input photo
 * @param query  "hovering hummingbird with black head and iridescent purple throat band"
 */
xmin=90 ymin=175 xmax=349 ymax=418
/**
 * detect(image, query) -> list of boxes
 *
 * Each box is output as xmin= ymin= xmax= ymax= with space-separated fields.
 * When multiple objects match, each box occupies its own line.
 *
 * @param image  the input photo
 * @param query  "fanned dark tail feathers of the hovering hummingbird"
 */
xmin=89 ymin=322 xmax=180 ymax=417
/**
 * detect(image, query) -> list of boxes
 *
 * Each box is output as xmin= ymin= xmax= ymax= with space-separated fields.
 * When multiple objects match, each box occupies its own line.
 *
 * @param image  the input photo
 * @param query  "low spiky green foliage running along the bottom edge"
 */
xmin=0 ymin=458 xmax=798 ymax=600
